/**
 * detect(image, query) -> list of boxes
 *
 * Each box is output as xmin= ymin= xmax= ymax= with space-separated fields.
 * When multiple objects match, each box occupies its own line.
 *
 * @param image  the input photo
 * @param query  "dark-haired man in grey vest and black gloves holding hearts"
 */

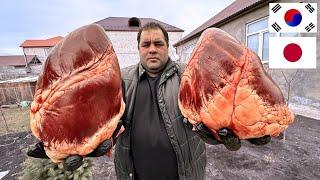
xmin=28 ymin=22 xmax=270 ymax=180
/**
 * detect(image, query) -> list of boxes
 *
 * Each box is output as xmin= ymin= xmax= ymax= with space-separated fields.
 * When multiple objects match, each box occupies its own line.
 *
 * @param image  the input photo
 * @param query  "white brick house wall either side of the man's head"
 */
xmin=106 ymin=31 xmax=182 ymax=68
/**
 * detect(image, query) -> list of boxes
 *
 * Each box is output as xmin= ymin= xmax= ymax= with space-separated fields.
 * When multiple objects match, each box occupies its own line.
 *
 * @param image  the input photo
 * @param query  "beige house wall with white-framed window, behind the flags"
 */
xmin=174 ymin=0 xmax=320 ymax=119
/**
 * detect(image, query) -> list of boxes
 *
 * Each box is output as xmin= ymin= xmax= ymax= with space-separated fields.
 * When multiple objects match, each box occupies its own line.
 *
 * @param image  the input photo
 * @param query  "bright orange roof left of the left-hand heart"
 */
xmin=20 ymin=36 xmax=63 ymax=47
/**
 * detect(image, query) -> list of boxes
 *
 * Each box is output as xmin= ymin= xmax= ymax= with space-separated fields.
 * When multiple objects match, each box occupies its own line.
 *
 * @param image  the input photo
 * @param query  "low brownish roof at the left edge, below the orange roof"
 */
xmin=0 ymin=55 xmax=37 ymax=66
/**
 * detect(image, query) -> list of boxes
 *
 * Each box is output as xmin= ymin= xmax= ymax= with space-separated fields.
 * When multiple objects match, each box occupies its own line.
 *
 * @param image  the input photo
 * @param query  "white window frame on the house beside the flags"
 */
xmin=245 ymin=16 xmax=270 ymax=64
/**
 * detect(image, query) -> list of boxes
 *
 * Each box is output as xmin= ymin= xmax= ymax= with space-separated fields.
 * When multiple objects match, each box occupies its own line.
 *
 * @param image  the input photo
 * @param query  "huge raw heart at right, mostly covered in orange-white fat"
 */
xmin=179 ymin=28 xmax=294 ymax=139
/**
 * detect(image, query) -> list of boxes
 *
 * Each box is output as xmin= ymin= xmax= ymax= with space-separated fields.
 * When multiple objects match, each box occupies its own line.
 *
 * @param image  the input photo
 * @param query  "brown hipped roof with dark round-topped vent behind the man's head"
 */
xmin=95 ymin=17 xmax=183 ymax=32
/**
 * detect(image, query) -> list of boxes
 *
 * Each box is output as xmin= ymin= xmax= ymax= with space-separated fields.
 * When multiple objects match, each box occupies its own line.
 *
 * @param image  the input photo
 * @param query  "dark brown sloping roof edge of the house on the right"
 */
xmin=173 ymin=0 xmax=276 ymax=46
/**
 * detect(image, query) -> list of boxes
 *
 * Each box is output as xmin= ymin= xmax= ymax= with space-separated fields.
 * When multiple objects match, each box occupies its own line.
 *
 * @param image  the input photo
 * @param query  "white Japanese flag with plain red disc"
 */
xmin=269 ymin=37 xmax=317 ymax=69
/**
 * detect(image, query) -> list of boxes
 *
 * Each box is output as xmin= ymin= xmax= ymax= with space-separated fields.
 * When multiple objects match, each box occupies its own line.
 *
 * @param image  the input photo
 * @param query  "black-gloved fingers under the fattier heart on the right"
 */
xmin=184 ymin=119 xmax=241 ymax=151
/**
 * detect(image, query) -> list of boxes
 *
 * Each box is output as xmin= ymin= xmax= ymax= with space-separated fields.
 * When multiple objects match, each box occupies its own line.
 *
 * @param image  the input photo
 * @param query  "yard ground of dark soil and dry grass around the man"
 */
xmin=0 ymin=109 xmax=320 ymax=180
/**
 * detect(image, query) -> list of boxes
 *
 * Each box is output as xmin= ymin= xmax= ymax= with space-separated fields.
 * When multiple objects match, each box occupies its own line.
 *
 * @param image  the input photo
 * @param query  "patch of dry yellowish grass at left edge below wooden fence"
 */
xmin=0 ymin=108 xmax=30 ymax=135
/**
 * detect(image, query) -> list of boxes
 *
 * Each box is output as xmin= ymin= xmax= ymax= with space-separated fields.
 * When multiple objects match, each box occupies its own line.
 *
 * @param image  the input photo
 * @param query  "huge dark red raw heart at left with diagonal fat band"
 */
xmin=30 ymin=25 xmax=125 ymax=162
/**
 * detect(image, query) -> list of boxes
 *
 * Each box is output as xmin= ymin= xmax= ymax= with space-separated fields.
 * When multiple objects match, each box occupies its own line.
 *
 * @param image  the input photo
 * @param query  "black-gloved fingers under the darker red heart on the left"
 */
xmin=27 ymin=121 xmax=124 ymax=171
